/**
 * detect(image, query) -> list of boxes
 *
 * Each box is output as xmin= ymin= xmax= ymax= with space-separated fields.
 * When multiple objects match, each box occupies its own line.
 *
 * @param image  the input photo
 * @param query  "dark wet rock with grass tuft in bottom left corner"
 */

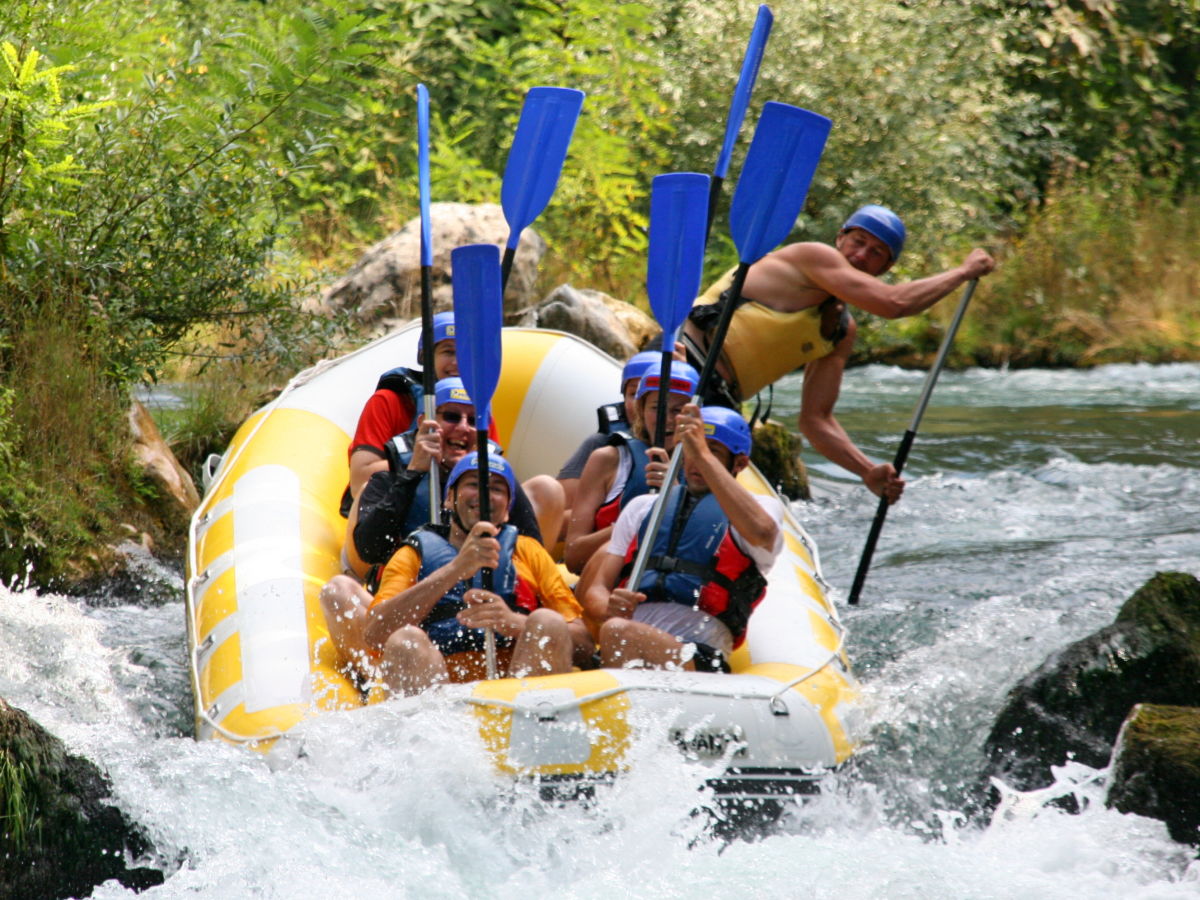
xmin=0 ymin=700 xmax=163 ymax=900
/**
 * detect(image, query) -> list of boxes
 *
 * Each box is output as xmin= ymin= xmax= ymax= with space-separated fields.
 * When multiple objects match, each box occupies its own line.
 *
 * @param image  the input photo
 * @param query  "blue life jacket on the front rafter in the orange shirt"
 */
xmin=404 ymin=524 xmax=538 ymax=656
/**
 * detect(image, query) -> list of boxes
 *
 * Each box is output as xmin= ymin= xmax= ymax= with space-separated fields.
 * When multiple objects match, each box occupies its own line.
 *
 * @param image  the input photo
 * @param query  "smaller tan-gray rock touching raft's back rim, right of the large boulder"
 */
xmin=514 ymin=284 xmax=661 ymax=360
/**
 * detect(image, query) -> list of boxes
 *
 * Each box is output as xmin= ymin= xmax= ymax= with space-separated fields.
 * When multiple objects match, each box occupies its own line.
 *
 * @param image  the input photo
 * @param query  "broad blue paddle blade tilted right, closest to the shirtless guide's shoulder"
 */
xmin=730 ymin=102 xmax=833 ymax=265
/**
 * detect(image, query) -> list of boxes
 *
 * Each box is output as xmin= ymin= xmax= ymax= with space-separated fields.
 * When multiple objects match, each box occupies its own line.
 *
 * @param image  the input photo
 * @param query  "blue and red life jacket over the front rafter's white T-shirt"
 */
xmin=622 ymin=488 xmax=767 ymax=647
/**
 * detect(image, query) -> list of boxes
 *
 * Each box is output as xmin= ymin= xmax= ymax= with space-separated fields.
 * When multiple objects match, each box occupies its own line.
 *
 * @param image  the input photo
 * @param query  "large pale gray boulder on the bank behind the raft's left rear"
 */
xmin=319 ymin=203 xmax=546 ymax=325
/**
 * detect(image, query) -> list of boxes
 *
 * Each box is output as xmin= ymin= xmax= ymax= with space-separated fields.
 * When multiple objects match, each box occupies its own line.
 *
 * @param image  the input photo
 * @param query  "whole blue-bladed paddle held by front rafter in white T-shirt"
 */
xmin=626 ymin=102 xmax=833 ymax=590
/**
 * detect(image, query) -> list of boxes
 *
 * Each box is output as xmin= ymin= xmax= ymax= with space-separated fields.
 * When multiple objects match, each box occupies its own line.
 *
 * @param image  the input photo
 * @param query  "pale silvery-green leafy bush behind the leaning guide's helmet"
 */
xmin=664 ymin=0 xmax=1045 ymax=277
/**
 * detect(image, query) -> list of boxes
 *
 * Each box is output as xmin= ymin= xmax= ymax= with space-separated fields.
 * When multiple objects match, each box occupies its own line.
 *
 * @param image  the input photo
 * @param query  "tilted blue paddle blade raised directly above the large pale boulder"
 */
xmin=500 ymin=88 xmax=583 ymax=248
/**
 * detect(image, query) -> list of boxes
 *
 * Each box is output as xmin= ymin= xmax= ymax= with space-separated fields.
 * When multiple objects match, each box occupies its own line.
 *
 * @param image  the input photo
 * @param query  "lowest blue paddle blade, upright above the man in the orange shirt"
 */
xmin=450 ymin=244 xmax=504 ymax=432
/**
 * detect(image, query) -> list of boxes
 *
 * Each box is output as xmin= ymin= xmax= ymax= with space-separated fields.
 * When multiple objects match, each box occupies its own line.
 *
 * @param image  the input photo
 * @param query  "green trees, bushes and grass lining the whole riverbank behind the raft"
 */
xmin=0 ymin=0 xmax=1200 ymax=583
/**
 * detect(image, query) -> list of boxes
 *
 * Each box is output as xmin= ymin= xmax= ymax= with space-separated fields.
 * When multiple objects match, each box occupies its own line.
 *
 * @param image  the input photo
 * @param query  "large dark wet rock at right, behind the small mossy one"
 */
xmin=985 ymin=572 xmax=1200 ymax=790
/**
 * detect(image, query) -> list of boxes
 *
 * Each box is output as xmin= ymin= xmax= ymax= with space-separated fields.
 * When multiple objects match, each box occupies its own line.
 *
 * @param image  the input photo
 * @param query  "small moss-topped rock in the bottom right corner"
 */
xmin=1108 ymin=703 xmax=1200 ymax=844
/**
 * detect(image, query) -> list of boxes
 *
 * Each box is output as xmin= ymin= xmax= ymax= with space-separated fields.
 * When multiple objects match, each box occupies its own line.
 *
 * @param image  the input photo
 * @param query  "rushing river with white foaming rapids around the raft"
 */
xmin=0 ymin=365 xmax=1200 ymax=900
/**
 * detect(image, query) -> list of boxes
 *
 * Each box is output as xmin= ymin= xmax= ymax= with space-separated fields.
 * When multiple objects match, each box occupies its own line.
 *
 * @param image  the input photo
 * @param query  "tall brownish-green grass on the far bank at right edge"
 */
xmin=966 ymin=168 xmax=1200 ymax=365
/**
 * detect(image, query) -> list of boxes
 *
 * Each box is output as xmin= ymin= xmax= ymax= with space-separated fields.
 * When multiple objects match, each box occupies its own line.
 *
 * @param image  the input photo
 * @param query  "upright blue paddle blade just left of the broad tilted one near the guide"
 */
xmin=646 ymin=172 xmax=709 ymax=350
